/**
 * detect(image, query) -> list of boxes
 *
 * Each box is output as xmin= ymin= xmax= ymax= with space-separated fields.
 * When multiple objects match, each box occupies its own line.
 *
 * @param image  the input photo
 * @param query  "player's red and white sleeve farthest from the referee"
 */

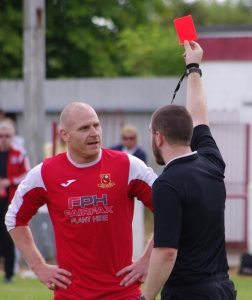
xmin=5 ymin=163 xmax=46 ymax=231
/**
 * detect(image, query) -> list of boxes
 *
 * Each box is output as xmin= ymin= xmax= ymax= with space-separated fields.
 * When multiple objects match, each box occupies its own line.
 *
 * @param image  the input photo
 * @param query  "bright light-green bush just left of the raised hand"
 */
xmin=118 ymin=24 xmax=184 ymax=76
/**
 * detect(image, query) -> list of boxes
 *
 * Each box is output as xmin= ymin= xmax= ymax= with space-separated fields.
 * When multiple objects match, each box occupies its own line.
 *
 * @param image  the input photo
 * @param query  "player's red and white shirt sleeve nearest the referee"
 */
xmin=128 ymin=154 xmax=157 ymax=211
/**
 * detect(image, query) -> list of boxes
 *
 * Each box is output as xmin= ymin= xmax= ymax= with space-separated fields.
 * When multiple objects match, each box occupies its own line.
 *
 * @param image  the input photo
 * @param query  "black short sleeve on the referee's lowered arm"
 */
xmin=153 ymin=179 xmax=182 ymax=249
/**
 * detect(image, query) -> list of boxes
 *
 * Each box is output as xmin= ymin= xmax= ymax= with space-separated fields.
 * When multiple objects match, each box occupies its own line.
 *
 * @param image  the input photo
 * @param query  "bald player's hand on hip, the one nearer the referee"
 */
xmin=116 ymin=258 xmax=149 ymax=286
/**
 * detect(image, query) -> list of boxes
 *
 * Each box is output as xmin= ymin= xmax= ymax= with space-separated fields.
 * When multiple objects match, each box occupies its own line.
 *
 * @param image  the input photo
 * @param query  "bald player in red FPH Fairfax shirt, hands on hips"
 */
xmin=6 ymin=102 xmax=156 ymax=300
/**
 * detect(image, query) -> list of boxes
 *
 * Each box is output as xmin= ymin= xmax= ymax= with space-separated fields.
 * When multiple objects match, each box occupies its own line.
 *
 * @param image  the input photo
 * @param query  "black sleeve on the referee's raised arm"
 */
xmin=191 ymin=125 xmax=226 ymax=174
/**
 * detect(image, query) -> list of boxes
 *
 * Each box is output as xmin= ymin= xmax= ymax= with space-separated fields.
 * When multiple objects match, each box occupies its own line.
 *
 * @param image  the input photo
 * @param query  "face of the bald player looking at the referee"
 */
xmin=65 ymin=109 xmax=102 ymax=163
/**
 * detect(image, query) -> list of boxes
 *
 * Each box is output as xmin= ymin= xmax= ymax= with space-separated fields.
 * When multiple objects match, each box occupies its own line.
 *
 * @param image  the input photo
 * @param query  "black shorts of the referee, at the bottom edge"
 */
xmin=161 ymin=275 xmax=236 ymax=300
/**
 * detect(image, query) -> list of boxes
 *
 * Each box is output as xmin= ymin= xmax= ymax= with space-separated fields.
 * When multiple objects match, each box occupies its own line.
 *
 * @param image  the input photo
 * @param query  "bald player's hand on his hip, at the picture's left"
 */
xmin=33 ymin=263 xmax=72 ymax=290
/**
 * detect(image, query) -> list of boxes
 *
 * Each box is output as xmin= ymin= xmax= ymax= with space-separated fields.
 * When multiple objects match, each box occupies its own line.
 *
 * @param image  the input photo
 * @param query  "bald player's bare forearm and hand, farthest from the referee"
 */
xmin=9 ymin=226 xmax=71 ymax=289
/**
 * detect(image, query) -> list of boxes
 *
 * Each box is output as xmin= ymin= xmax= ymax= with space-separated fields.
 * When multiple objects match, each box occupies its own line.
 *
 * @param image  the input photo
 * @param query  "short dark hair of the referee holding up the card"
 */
xmin=151 ymin=105 xmax=193 ymax=146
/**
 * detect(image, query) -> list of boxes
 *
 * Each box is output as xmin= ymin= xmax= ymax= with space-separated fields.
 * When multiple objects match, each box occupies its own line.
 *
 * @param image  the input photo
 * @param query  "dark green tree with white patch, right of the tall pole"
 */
xmin=47 ymin=0 xmax=158 ymax=77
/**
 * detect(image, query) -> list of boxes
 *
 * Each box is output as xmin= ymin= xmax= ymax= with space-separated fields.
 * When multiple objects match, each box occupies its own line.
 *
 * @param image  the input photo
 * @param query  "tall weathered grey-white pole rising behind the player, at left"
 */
xmin=23 ymin=0 xmax=45 ymax=166
